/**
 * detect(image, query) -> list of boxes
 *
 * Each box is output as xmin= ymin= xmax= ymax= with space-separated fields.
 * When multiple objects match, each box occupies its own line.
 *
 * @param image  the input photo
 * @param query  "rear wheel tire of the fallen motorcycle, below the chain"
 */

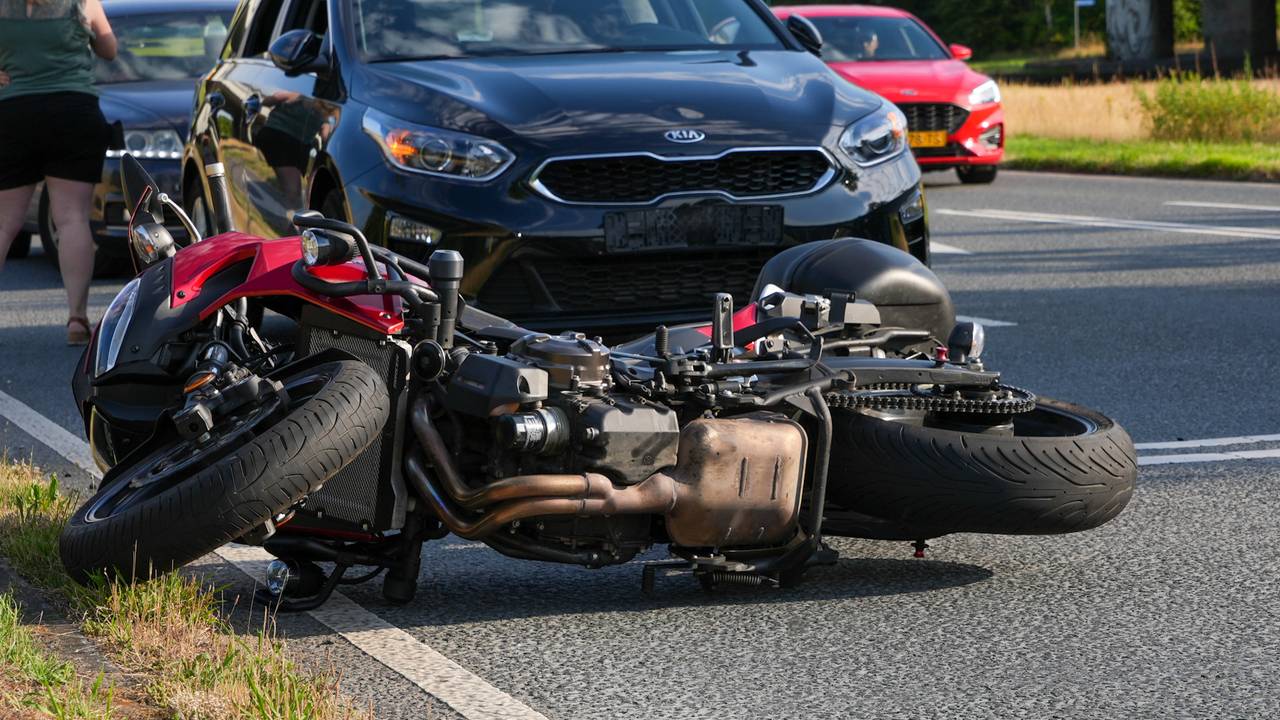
xmin=828 ymin=398 xmax=1138 ymax=539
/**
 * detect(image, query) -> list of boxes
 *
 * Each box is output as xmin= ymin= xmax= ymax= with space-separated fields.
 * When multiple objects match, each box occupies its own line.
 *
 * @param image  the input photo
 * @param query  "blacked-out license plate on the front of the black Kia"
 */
xmin=604 ymin=205 xmax=782 ymax=252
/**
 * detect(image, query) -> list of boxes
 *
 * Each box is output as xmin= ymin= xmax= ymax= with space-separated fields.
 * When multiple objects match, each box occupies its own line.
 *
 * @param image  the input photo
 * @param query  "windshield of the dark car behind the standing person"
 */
xmin=95 ymin=10 xmax=230 ymax=83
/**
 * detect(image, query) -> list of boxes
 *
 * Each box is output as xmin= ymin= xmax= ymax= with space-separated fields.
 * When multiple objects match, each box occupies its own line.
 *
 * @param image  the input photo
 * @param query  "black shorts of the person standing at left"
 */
xmin=0 ymin=92 xmax=111 ymax=190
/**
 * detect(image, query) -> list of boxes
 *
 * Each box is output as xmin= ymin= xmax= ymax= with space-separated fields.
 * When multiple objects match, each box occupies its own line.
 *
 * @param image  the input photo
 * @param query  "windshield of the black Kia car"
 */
xmin=351 ymin=0 xmax=783 ymax=61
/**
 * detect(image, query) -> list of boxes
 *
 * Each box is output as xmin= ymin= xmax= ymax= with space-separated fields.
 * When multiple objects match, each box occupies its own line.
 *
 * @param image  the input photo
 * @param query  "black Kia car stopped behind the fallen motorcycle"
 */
xmin=183 ymin=0 xmax=929 ymax=333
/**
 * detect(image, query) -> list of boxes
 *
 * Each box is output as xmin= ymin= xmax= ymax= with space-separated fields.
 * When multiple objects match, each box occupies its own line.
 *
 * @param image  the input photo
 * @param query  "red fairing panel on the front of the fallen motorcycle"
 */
xmin=169 ymin=232 xmax=404 ymax=334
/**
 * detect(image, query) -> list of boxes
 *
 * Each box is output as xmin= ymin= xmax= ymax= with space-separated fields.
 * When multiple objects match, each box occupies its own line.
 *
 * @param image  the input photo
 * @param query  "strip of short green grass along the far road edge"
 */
xmin=1005 ymin=135 xmax=1280 ymax=182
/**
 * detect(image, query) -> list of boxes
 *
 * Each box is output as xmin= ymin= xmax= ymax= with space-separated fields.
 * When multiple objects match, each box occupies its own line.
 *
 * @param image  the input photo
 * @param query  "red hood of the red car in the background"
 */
xmin=831 ymin=60 xmax=988 ymax=105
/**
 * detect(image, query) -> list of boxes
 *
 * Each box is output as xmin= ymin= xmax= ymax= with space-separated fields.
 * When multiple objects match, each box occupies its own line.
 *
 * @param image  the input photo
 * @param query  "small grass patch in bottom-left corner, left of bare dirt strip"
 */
xmin=0 ymin=593 xmax=115 ymax=720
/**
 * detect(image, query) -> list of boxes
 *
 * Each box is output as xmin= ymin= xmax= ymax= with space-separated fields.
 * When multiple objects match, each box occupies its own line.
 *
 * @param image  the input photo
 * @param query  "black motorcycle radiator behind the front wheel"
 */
xmin=297 ymin=307 xmax=412 ymax=532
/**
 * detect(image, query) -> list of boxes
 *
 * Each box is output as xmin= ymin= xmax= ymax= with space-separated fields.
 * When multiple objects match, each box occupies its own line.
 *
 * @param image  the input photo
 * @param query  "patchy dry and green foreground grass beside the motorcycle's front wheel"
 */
xmin=0 ymin=457 xmax=371 ymax=720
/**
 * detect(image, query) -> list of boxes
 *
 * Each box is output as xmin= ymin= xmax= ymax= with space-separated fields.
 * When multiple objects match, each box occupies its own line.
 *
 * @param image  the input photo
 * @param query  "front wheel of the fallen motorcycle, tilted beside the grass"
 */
xmin=59 ymin=360 xmax=390 ymax=583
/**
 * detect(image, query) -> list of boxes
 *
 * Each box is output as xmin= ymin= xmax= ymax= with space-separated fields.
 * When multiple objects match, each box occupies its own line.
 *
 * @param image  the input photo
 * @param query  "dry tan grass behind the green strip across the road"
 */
xmin=1001 ymin=78 xmax=1280 ymax=141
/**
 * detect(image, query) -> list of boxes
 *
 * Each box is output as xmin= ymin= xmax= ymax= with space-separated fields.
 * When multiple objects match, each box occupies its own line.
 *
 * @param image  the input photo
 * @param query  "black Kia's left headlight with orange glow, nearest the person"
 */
xmin=364 ymin=108 xmax=516 ymax=181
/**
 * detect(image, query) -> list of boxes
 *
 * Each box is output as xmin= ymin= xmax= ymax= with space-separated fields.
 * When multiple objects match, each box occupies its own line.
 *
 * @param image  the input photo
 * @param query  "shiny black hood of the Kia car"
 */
xmin=351 ymin=50 xmax=882 ymax=150
